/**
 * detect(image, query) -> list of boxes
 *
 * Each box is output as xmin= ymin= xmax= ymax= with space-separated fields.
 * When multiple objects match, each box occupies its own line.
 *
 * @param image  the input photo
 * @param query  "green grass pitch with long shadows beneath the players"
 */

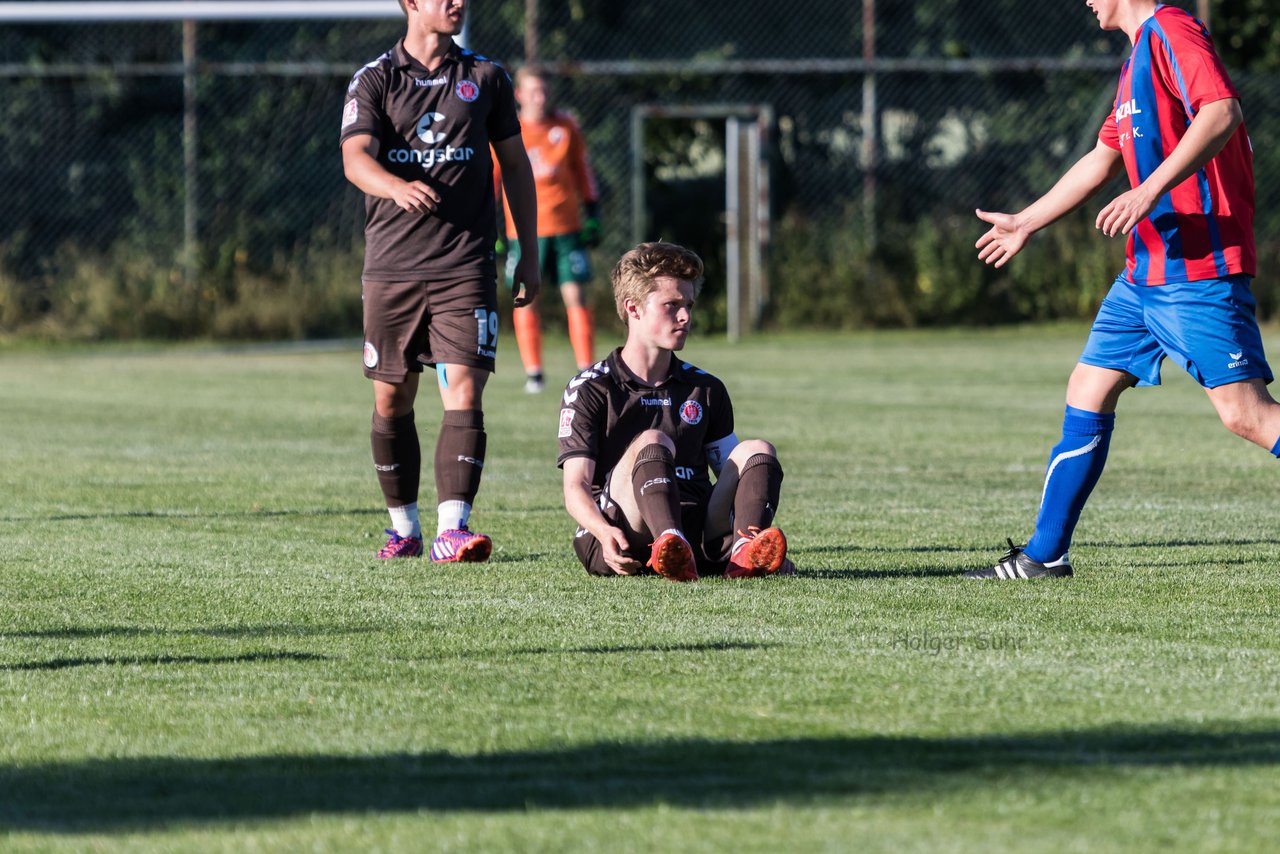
xmin=0 ymin=326 xmax=1280 ymax=853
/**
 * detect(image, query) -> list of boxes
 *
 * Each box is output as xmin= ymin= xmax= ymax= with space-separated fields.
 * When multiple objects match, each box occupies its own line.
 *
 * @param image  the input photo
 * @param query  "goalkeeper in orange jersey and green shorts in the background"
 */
xmin=494 ymin=68 xmax=600 ymax=393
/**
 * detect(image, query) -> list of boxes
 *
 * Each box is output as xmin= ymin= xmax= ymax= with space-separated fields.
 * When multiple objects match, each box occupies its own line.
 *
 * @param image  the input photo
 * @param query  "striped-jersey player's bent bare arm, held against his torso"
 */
xmin=1094 ymin=97 xmax=1244 ymax=237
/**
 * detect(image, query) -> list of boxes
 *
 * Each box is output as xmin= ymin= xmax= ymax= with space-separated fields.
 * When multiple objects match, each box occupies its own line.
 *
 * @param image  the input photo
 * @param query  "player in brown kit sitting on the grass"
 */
xmin=557 ymin=243 xmax=795 ymax=581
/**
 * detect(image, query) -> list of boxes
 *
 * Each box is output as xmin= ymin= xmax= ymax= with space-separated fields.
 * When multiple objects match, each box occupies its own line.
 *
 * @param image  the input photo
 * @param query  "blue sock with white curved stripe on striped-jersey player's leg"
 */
xmin=1025 ymin=406 xmax=1116 ymax=563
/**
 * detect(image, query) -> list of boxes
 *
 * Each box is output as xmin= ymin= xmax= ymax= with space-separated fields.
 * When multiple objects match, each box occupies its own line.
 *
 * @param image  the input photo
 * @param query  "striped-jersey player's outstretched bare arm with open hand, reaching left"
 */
xmin=975 ymin=141 xmax=1124 ymax=268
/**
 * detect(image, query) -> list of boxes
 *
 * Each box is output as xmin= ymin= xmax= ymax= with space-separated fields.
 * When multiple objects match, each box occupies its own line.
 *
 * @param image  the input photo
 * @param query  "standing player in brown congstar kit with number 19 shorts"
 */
xmin=340 ymin=0 xmax=539 ymax=562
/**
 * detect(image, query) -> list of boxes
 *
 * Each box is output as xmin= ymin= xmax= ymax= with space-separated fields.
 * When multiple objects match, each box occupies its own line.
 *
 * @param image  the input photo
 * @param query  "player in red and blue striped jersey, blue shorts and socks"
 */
xmin=965 ymin=0 xmax=1280 ymax=579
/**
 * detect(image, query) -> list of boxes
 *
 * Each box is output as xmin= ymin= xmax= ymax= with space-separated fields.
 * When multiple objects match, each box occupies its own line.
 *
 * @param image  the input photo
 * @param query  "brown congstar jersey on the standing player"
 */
xmin=339 ymin=40 xmax=520 ymax=282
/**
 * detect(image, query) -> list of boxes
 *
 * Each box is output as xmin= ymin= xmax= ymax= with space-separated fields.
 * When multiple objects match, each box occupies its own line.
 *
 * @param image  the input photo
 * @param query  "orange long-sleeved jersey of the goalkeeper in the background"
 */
xmin=493 ymin=113 xmax=600 ymax=239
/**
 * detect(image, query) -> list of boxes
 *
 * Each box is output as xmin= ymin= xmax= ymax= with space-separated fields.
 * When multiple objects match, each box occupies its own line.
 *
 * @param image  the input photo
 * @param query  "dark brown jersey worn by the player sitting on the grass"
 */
xmin=557 ymin=348 xmax=733 ymax=503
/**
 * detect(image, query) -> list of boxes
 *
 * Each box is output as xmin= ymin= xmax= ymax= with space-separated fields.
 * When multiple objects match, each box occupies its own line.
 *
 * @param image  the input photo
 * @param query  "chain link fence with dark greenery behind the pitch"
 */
xmin=0 ymin=0 xmax=1280 ymax=338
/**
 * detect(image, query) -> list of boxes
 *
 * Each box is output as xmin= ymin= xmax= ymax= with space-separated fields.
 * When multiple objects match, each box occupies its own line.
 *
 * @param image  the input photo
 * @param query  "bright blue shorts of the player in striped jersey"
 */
xmin=1080 ymin=275 xmax=1272 ymax=388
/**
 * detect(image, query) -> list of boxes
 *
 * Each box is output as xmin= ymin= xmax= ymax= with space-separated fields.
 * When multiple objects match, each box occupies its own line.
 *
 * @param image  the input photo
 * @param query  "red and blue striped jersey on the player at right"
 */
xmin=1098 ymin=5 xmax=1256 ymax=286
